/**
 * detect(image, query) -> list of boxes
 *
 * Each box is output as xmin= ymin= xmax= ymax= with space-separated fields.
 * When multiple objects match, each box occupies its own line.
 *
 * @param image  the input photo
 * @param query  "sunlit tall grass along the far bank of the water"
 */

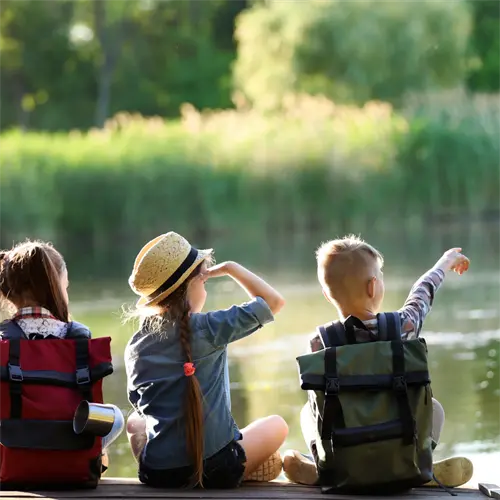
xmin=0 ymin=91 xmax=500 ymax=274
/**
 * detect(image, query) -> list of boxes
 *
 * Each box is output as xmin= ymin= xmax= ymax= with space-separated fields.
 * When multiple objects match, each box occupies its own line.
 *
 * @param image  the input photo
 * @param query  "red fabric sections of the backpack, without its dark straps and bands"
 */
xmin=0 ymin=337 xmax=111 ymax=485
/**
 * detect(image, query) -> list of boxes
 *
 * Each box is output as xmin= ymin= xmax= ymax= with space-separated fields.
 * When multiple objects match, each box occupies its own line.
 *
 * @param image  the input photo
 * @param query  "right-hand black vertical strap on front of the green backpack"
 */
xmin=391 ymin=338 xmax=416 ymax=445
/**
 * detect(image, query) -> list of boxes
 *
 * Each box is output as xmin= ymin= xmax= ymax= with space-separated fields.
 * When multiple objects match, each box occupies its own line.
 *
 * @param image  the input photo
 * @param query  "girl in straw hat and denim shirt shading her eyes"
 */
xmin=125 ymin=232 xmax=288 ymax=488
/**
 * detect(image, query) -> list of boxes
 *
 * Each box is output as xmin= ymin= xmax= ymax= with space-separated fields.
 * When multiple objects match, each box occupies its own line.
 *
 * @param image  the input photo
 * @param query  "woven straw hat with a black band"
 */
xmin=128 ymin=231 xmax=212 ymax=307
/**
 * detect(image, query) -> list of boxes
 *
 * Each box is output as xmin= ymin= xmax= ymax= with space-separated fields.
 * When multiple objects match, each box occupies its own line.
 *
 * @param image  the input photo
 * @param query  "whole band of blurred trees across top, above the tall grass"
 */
xmin=0 ymin=0 xmax=500 ymax=130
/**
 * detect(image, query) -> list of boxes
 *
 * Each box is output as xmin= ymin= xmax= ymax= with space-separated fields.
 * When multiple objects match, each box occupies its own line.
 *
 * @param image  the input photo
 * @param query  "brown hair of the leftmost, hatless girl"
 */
xmin=0 ymin=240 xmax=69 ymax=323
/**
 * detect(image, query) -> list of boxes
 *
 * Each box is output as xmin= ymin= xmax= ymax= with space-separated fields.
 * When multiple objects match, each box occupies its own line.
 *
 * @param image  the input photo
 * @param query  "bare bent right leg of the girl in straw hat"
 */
xmin=241 ymin=415 xmax=288 ymax=478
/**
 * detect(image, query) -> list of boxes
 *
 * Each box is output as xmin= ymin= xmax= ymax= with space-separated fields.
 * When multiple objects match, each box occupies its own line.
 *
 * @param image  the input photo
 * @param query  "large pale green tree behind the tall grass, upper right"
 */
xmin=234 ymin=0 xmax=470 ymax=109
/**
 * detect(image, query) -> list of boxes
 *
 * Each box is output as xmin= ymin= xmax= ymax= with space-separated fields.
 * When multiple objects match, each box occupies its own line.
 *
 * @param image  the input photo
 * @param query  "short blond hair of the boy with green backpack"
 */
xmin=316 ymin=235 xmax=384 ymax=302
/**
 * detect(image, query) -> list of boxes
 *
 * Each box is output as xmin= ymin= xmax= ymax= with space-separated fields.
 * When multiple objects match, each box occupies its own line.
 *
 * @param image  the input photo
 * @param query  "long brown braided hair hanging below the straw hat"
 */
xmin=149 ymin=263 xmax=205 ymax=487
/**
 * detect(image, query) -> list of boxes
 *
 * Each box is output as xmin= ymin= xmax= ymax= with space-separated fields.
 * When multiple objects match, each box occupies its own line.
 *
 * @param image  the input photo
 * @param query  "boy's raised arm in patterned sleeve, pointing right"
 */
xmin=399 ymin=248 xmax=469 ymax=340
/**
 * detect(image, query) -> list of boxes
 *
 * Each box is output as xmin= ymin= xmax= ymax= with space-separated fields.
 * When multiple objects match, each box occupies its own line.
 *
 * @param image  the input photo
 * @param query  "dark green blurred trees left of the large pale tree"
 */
xmin=0 ymin=0 xmax=247 ymax=130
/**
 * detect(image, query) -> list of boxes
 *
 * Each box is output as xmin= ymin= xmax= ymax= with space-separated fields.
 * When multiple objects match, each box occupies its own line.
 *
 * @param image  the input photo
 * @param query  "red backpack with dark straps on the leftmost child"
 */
xmin=0 ymin=321 xmax=113 ymax=489
